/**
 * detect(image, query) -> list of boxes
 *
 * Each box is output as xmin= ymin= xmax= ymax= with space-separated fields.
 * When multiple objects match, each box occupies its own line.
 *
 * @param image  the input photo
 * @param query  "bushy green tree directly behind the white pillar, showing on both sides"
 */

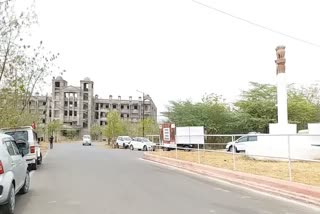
xmin=234 ymin=82 xmax=319 ymax=132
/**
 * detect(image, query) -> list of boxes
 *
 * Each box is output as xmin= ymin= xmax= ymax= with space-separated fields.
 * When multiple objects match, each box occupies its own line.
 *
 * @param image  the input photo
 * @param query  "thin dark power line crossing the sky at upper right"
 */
xmin=192 ymin=0 xmax=320 ymax=48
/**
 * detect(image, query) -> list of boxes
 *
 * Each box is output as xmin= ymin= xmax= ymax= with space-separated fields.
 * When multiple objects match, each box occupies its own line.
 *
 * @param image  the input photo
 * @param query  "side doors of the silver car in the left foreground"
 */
xmin=5 ymin=140 xmax=26 ymax=189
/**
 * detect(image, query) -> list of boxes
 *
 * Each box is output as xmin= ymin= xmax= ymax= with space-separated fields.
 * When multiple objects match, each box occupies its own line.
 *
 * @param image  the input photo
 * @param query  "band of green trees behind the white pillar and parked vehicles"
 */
xmin=166 ymin=82 xmax=320 ymax=134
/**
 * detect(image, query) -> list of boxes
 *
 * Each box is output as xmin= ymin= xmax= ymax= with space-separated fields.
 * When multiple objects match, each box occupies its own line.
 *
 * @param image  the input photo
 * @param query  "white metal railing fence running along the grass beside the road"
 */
xmin=148 ymin=134 xmax=320 ymax=186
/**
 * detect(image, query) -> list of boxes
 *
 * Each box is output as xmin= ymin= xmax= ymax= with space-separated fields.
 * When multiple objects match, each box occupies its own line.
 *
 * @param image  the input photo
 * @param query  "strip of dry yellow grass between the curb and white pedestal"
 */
xmin=154 ymin=151 xmax=320 ymax=186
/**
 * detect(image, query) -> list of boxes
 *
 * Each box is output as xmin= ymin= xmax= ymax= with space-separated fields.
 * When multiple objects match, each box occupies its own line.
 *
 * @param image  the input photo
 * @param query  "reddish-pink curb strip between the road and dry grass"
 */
xmin=143 ymin=153 xmax=320 ymax=206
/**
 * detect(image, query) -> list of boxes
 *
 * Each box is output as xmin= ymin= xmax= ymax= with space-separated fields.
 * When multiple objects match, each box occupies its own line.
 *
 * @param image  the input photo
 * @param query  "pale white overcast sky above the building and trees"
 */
xmin=19 ymin=0 xmax=320 ymax=113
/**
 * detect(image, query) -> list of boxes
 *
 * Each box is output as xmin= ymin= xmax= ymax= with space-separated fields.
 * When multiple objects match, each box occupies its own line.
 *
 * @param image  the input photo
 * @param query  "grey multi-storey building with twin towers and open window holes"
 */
xmin=29 ymin=76 xmax=157 ymax=134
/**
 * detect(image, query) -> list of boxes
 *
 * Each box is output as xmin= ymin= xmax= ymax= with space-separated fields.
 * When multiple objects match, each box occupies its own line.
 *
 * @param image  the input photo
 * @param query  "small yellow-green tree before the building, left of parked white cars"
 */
xmin=103 ymin=111 xmax=124 ymax=146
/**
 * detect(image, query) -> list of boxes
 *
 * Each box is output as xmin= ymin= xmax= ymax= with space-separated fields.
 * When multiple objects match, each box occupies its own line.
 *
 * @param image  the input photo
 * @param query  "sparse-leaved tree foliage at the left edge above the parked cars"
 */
xmin=0 ymin=0 xmax=61 ymax=129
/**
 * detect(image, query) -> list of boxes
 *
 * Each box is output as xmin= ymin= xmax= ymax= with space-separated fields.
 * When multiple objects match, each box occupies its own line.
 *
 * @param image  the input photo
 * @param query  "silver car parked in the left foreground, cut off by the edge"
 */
xmin=0 ymin=134 xmax=30 ymax=214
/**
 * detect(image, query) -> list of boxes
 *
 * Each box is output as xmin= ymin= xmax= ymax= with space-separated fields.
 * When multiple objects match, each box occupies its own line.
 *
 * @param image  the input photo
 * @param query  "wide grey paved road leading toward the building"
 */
xmin=16 ymin=144 xmax=319 ymax=214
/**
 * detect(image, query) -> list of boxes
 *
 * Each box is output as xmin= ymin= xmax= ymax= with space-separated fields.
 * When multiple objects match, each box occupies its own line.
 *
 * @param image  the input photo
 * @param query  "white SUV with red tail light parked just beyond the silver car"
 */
xmin=0 ymin=126 xmax=42 ymax=170
